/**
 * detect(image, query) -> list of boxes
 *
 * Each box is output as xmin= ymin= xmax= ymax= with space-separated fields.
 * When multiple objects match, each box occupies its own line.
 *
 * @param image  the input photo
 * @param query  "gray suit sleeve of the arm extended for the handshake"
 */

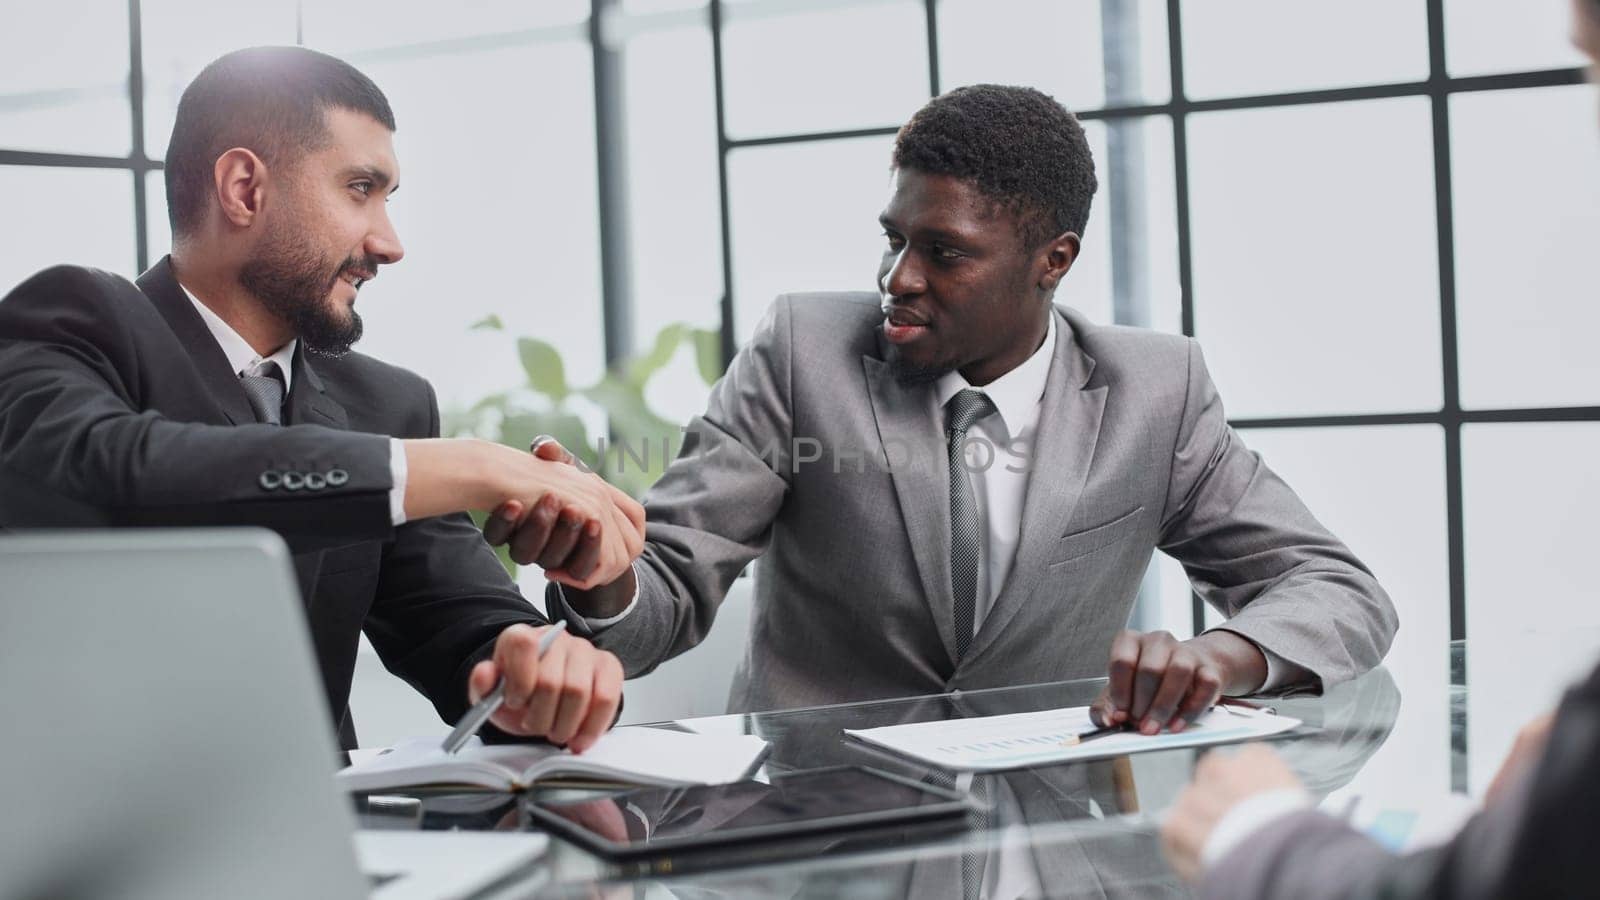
xmin=546 ymin=296 xmax=794 ymax=677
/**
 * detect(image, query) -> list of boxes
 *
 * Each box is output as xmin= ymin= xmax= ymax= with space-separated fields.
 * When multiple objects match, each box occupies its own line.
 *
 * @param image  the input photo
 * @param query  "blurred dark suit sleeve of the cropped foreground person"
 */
xmin=1200 ymin=668 xmax=1600 ymax=900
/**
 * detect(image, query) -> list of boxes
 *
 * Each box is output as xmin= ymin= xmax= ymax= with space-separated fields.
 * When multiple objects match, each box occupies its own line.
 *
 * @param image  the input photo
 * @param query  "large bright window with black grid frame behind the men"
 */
xmin=0 ymin=0 xmax=1600 ymax=788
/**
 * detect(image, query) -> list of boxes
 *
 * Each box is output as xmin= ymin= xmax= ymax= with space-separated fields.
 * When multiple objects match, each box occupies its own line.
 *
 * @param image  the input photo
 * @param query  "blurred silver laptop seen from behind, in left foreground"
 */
xmin=0 ymin=528 xmax=546 ymax=900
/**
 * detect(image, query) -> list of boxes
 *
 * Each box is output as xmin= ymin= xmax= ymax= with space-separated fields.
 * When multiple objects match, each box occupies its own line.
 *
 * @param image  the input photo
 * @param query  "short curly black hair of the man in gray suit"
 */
xmin=893 ymin=85 xmax=1099 ymax=247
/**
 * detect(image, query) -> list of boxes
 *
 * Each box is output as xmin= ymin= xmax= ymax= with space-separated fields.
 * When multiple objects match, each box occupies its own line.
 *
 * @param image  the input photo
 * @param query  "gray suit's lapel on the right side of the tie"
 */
xmin=966 ymin=312 xmax=1107 ymax=658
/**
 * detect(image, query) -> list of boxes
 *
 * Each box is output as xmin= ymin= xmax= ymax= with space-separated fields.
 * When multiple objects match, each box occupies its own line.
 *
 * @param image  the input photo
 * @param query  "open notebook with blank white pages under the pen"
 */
xmin=334 ymin=727 xmax=766 ymax=791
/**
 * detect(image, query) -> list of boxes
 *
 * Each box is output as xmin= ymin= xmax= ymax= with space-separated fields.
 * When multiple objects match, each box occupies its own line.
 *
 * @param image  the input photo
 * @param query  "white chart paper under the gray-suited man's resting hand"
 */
xmin=845 ymin=705 xmax=1301 ymax=772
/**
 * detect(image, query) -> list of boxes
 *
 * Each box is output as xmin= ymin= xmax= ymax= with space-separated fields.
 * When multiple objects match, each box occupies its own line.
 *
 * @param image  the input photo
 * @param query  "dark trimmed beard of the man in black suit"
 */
xmin=238 ymin=219 xmax=378 ymax=357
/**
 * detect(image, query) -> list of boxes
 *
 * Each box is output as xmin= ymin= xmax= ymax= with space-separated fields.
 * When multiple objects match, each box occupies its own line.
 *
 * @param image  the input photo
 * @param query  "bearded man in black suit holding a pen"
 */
xmin=0 ymin=48 xmax=643 ymax=751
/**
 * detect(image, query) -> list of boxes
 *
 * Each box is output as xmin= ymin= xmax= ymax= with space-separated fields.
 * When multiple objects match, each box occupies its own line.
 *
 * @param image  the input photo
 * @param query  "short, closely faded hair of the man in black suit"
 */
xmin=166 ymin=46 xmax=395 ymax=237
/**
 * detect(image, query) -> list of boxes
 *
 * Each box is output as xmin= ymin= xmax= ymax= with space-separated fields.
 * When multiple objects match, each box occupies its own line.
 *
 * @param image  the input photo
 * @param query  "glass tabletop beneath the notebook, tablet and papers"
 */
xmin=358 ymin=650 xmax=1433 ymax=898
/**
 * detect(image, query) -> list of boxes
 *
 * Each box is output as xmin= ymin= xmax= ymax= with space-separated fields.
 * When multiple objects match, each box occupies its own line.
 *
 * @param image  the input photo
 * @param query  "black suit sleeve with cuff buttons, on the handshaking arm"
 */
xmin=0 ymin=267 xmax=392 ymax=552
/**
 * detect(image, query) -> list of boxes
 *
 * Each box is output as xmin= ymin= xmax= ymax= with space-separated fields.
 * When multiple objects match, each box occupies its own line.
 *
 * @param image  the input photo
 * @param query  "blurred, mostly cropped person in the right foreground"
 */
xmin=1162 ymin=0 xmax=1600 ymax=900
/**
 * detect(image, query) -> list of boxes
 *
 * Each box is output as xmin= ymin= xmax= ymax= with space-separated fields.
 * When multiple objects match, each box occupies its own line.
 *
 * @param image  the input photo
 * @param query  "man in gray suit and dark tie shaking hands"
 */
xmin=505 ymin=85 xmax=1395 ymax=732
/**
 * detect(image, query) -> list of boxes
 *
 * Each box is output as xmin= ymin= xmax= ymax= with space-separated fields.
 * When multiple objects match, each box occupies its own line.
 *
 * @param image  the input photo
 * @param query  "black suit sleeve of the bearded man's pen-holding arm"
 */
xmin=363 ymin=374 xmax=547 ymax=723
